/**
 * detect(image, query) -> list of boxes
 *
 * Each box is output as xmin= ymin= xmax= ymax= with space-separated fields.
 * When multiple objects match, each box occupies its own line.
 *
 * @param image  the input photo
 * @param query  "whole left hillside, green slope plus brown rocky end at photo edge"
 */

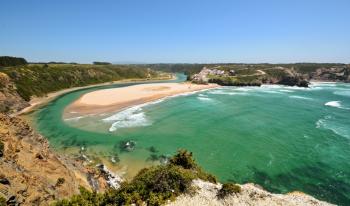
xmin=0 ymin=64 xmax=170 ymax=113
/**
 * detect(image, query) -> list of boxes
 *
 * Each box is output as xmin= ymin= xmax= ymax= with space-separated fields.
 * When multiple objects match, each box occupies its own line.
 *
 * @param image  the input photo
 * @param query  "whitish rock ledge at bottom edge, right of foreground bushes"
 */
xmin=167 ymin=180 xmax=332 ymax=206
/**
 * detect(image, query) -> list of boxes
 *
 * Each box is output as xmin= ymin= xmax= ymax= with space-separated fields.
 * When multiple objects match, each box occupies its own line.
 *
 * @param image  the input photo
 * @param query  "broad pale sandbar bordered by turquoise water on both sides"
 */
xmin=64 ymin=83 xmax=219 ymax=118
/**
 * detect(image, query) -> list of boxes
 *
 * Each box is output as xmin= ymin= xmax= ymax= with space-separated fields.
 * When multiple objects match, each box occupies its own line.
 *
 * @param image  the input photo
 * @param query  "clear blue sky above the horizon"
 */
xmin=0 ymin=0 xmax=350 ymax=63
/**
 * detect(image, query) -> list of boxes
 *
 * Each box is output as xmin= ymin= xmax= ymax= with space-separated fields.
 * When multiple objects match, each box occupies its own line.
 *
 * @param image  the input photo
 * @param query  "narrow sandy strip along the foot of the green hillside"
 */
xmin=11 ymin=75 xmax=176 ymax=117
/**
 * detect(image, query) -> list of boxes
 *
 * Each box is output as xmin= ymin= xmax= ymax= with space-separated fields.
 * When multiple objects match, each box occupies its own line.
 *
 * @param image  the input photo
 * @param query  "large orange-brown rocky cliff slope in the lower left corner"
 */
xmin=0 ymin=114 xmax=104 ymax=205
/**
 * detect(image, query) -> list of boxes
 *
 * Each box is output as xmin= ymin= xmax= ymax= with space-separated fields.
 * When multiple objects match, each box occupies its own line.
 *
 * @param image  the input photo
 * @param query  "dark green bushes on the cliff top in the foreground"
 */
xmin=54 ymin=150 xmax=216 ymax=206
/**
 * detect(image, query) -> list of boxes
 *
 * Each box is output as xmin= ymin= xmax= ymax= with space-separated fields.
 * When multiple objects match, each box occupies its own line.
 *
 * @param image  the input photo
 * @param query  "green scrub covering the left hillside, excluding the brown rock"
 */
xmin=0 ymin=64 xmax=164 ymax=101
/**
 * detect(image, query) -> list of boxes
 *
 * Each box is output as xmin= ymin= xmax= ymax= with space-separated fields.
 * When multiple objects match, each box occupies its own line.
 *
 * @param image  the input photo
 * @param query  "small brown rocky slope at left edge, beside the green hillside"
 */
xmin=0 ymin=72 xmax=29 ymax=113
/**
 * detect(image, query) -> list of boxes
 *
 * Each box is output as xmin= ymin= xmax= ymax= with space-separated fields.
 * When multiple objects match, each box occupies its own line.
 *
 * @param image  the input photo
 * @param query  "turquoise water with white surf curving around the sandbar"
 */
xmin=34 ymin=76 xmax=350 ymax=205
